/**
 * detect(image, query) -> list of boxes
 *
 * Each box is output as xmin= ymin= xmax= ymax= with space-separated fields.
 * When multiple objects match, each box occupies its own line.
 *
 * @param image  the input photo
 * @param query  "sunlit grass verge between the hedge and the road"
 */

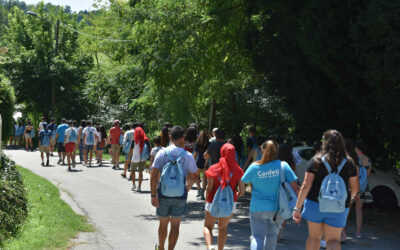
xmin=4 ymin=166 xmax=94 ymax=249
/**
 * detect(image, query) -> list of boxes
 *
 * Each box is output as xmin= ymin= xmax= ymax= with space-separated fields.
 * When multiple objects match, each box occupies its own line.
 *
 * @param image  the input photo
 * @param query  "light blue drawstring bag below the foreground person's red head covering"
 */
xmin=210 ymin=173 xmax=234 ymax=218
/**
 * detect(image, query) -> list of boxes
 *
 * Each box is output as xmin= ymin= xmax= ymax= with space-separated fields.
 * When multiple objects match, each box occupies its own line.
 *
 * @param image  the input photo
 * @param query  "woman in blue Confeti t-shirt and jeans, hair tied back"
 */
xmin=242 ymin=141 xmax=299 ymax=250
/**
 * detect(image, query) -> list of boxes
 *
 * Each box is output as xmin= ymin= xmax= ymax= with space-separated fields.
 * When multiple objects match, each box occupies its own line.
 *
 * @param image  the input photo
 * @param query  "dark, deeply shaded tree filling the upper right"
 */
xmin=246 ymin=0 xmax=400 ymax=167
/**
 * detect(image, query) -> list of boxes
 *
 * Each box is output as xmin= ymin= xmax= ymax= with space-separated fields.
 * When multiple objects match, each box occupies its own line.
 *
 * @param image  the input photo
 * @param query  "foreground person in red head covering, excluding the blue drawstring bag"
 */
xmin=203 ymin=143 xmax=246 ymax=249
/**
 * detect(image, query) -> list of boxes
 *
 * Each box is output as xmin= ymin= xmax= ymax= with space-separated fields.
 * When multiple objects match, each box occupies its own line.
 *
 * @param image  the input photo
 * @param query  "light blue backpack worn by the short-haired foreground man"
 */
xmin=160 ymin=149 xmax=187 ymax=197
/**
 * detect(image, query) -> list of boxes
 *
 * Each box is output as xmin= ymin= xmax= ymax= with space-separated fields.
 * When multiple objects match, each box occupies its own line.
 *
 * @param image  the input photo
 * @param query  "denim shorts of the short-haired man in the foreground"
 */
xmin=157 ymin=197 xmax=186 ymax=218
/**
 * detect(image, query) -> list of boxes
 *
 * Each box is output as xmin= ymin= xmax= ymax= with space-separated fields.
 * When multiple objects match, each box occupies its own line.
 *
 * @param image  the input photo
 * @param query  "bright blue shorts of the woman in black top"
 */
xmin=302 ymin=199 xmax=349 ymax=227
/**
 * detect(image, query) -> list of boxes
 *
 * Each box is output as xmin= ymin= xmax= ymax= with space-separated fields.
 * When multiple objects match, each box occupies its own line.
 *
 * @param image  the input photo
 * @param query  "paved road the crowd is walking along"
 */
xmin=5 ymin=150 xmax=400 ymax=250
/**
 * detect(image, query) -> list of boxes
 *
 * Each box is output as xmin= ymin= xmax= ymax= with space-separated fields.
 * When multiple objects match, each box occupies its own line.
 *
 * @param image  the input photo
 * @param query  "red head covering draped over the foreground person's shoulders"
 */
xmin=206 ymin=143 xmax=243 ymax=189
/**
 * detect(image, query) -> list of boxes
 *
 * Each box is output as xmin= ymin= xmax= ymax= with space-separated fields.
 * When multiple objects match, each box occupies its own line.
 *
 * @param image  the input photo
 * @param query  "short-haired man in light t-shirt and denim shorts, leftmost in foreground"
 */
xmin=150 ymin=126 xmax=197 ymax=250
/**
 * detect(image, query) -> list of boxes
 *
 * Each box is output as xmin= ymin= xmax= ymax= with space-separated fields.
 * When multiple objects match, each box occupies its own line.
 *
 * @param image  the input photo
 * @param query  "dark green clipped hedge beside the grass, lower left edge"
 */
xmin=0 ymin=155 xmax=28 ymax=246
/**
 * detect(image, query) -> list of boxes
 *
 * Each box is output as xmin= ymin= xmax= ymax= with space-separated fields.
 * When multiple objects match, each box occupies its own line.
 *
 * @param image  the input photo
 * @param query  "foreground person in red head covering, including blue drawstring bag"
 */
xmin=203 ymin=143 xmax=246 ymax=249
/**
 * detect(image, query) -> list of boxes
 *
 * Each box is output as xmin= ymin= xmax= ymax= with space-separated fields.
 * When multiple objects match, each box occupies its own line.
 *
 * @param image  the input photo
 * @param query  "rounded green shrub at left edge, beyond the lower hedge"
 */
xmin=0 ymin=74 xmax=15 ymax=140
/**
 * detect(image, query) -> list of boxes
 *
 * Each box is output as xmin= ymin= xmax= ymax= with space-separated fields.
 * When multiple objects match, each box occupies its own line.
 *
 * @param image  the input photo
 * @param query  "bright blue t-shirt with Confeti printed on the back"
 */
xmin=242 ymin=160 xmax=297 ymax=212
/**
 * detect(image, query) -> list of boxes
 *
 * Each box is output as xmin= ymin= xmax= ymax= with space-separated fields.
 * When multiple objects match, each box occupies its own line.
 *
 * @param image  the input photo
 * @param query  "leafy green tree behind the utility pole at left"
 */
xmin=1 ymin=3 xmax=93 ymax=119
